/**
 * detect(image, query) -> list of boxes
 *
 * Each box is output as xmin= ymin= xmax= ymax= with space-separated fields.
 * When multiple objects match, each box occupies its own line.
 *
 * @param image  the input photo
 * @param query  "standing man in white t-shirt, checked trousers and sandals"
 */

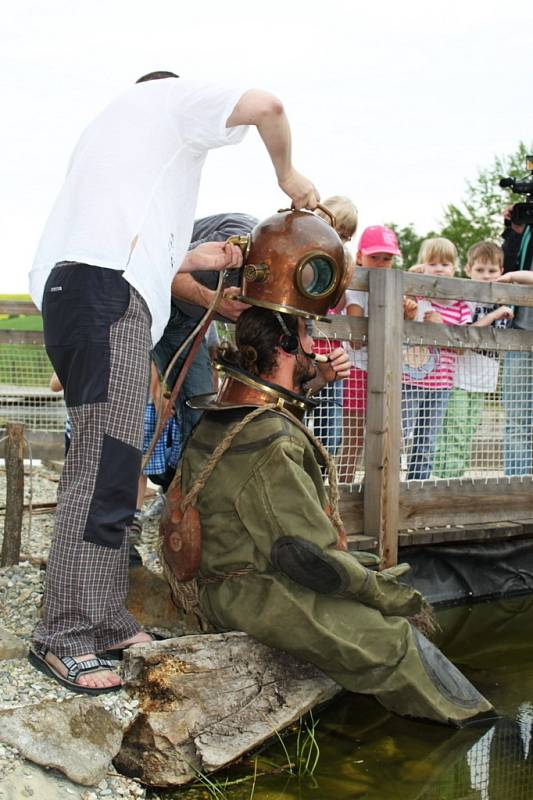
xmin=30 ymin=72 xmax=320 ymax=694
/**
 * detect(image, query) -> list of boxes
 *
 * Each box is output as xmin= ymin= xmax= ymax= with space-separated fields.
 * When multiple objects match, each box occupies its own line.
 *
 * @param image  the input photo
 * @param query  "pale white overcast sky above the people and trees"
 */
xmin=0 ymin=0 xmax=533 ymax=292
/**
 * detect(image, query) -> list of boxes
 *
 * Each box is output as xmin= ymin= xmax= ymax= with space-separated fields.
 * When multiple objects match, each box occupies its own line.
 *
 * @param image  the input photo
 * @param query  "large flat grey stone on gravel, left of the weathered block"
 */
xmin=0 ymin=697 xmax=123 ymax=784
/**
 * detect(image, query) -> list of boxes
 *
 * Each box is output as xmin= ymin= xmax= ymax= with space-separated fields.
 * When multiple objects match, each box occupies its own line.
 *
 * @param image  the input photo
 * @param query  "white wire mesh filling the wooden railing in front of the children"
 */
xmin=310 ymin=345 xmax=533 ymax=485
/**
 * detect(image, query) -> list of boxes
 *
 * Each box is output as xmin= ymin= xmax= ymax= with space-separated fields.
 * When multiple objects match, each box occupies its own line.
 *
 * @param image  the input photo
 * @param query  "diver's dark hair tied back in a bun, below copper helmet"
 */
xmin=218 ymin=306 xmax=298 ymax=377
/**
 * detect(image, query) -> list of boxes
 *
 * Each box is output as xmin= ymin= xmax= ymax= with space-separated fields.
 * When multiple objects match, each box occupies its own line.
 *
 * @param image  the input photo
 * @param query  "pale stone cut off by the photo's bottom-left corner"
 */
xmin=0 ymin=762 xmax=87 ymax=800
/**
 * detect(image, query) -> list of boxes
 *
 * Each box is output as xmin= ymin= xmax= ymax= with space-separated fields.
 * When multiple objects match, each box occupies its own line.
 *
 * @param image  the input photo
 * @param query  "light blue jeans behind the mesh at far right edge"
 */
xmin=502 ymin=350 xmax=533 ymax=476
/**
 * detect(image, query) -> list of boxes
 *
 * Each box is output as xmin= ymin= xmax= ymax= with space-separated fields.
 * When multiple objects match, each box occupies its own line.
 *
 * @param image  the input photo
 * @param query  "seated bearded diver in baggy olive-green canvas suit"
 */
xmin=162 ymin=205 xmax=492 ymax=725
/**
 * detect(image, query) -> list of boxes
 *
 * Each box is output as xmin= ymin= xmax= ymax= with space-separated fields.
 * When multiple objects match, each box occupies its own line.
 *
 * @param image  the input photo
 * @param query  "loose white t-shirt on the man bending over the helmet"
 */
xmin=30 ymin=78 xmax=247 ymax=344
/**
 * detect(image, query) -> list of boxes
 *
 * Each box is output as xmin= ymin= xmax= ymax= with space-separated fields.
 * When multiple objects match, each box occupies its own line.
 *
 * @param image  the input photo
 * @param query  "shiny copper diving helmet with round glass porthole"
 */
xmin=232 ymin=206 xmax=352 ymax=322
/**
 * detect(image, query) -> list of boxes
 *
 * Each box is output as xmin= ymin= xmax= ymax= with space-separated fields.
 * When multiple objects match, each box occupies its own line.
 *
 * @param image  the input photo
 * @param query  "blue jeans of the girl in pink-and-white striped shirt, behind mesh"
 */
xmin=402 ymin=385 xmax=451 ymax=481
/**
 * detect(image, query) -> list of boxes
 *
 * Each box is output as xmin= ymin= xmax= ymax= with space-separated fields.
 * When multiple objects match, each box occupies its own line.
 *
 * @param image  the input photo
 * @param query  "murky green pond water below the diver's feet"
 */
xmin=159 ymin=596 xmax=533 ymax=800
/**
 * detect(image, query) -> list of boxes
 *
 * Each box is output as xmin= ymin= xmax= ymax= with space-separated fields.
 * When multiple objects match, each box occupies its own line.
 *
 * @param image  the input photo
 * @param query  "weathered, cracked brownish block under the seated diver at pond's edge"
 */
xmin=115 ymin=632 xmax=341 ymax=787
